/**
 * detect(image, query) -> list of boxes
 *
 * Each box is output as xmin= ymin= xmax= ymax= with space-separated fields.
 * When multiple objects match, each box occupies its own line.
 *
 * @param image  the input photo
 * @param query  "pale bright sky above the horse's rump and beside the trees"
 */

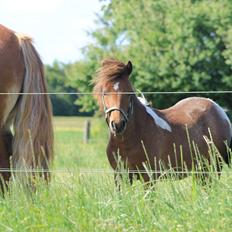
xmin=0 ymin=0 xmax=101 ymax=64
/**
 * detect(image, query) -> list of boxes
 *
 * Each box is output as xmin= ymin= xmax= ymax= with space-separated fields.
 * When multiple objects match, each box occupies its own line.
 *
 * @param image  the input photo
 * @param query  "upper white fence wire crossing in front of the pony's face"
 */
xmin=0 ymin=90 xmax=232 ymax=95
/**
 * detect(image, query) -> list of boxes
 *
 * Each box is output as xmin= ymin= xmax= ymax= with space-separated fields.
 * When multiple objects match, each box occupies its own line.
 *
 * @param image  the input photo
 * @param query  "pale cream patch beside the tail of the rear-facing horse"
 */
xmin=3 ymin=86 xmax=20 ymax=124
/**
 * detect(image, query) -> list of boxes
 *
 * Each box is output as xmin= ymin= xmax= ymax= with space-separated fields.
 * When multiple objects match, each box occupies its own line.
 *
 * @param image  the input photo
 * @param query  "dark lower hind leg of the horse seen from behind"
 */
xmin=0 ymin=131 xmax=13 ymax=193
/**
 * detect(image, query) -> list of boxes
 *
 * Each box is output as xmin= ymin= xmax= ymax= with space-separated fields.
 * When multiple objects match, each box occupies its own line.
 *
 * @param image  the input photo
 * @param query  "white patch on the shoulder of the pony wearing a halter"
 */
xmin=138 ymin=97 xmax=172 ymax=132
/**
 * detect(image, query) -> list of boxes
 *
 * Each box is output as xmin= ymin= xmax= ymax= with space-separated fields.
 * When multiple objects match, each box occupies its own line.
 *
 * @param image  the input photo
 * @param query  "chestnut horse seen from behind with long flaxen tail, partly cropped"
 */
xmin=0 ymin=25 xmax=53 ymax=188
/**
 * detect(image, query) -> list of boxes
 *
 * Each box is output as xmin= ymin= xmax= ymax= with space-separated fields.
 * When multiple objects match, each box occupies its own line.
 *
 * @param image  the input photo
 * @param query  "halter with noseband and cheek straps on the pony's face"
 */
xmin=102 ymin=93 xmax=133 ymax=125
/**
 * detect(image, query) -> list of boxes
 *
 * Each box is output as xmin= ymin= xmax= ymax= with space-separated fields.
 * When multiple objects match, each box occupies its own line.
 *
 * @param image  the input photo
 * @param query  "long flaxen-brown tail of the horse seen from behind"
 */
xmin=12 ymin=34 xmax=53 ymax=174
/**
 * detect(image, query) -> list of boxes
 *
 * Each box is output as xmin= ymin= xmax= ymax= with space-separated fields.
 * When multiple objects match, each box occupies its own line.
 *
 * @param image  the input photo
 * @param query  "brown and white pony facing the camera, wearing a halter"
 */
xmin=94 ymin=59 xmax=232 ymax=183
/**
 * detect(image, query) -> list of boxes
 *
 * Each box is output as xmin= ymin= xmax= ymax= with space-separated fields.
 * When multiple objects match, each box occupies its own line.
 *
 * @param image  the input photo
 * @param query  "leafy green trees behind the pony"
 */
xmin=46 ymin=0 xmax=232 ymax=115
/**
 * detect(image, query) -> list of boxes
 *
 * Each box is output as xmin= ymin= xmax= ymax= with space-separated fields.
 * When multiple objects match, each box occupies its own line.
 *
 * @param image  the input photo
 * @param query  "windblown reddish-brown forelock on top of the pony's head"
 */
xmin=94 ymin=59 xmax=126 ymax=93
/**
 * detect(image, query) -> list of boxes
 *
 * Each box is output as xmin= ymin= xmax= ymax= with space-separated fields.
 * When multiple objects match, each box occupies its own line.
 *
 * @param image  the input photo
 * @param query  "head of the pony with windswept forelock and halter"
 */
xmin=94 ymin=59 xmax=134 ymax=135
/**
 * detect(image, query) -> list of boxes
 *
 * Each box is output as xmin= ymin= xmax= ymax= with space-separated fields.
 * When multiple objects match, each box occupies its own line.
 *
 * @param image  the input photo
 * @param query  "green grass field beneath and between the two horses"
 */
xmin=0 ymin=117 xmax=232 ymax=232
